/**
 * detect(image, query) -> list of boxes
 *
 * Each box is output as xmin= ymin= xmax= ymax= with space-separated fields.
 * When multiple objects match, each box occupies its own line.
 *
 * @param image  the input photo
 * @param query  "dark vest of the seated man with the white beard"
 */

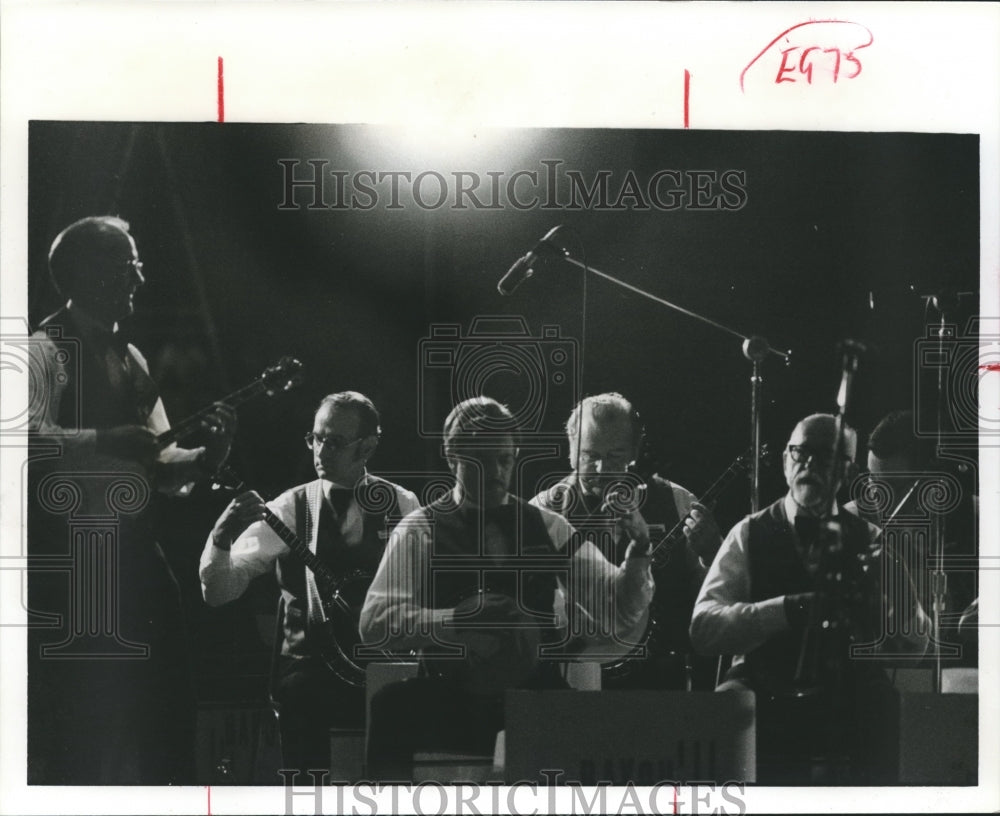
xmin=737 ymin=498 xmax=877 ymax=691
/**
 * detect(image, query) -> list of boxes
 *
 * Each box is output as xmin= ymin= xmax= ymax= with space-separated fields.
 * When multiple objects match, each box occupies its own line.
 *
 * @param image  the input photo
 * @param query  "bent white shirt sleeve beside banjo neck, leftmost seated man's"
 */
xmin=198 ymin=484 xmax=296 ymax=606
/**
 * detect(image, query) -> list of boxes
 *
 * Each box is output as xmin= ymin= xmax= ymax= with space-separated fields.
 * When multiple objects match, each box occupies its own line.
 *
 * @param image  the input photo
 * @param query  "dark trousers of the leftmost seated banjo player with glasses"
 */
xmin=274 ymin=657 xmax=365 ymax=771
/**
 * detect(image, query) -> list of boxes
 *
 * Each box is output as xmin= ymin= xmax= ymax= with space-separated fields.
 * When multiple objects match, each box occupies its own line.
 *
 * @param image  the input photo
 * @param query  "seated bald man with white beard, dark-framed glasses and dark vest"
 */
xmin=691 ymin=414 xmax=926 ymax=784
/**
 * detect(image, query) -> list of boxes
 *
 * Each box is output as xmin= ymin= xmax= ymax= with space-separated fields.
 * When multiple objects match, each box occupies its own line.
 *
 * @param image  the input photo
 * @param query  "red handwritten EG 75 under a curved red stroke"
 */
xmin=740 ymin=20 xmax=875 ymax=92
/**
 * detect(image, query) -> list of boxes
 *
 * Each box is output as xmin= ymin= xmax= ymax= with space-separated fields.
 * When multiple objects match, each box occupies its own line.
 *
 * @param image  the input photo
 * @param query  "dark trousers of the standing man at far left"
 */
xmin=27 ymin=540 xmax=197 ymax=785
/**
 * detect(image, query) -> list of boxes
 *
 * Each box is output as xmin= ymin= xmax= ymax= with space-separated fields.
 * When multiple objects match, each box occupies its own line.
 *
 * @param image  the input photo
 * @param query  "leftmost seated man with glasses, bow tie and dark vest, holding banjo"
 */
xmin=200 ymin=391 xmax=420 ymax=770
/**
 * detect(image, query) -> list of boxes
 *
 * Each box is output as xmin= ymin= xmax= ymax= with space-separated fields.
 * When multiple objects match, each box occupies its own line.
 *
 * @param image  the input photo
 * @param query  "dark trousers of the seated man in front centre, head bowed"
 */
xmin=367 ymin=677 xmax=504 ymax=782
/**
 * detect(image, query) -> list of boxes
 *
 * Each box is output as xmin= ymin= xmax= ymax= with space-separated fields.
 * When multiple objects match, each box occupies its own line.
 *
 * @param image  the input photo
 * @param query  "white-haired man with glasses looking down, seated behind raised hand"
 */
xmin=531 ymin=392 xmax=722 ymax=690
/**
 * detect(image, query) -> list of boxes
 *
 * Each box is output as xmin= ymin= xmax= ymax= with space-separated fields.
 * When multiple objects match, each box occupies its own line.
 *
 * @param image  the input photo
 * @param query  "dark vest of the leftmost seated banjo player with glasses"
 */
xmin=275 ymin=475 xmax=401 ymax=655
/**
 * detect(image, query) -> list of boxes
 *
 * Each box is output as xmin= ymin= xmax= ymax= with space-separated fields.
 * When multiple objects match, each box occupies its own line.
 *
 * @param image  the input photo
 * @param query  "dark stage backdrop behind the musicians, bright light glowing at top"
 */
xmin=28 ymin=122 xmax=979 ymax=712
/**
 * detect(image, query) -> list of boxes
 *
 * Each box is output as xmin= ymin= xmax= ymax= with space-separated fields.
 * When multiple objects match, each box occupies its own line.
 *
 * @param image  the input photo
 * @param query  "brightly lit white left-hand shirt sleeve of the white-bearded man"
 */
xmin=691 ymin=519 xmax=788 ymax=655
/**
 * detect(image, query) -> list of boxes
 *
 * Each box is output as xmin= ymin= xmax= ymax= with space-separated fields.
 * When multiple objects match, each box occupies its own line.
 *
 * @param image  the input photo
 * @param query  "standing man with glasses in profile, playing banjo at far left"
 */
xmin=28 ymin=216 xmax=236 ymax=785
